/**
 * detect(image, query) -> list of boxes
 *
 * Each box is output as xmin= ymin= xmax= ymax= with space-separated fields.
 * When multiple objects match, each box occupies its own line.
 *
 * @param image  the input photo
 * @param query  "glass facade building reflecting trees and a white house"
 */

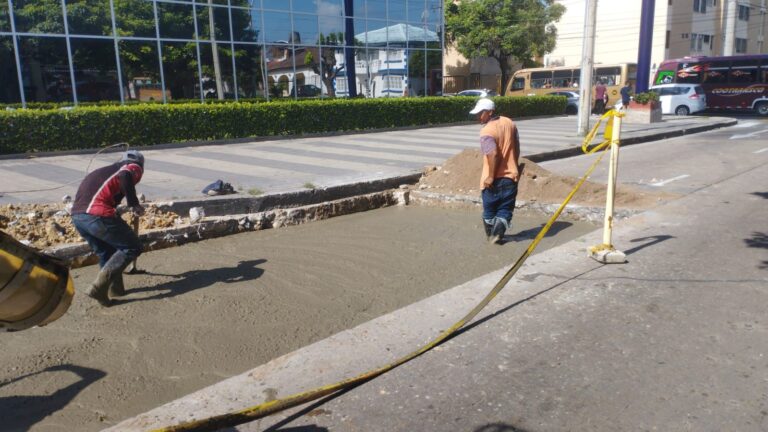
xmin=0 ymin=0 xmax=443 ymax=103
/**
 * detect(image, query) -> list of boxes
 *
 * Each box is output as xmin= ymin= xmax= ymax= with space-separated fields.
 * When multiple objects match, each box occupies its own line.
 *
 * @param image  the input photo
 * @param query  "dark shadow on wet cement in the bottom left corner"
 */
xmin=0 ymin=364 xmax=107 ymax=431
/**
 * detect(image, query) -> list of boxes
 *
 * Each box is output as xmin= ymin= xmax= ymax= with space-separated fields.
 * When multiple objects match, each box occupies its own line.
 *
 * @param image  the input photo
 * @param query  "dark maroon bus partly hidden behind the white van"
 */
xmin=653 ymin=54 xmax=768 ymax=116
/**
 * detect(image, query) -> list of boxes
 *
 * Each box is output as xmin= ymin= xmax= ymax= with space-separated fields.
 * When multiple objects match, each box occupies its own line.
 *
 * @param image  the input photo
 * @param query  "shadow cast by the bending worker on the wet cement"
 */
xmin=114 ymin=259 xmax=267 ymax=305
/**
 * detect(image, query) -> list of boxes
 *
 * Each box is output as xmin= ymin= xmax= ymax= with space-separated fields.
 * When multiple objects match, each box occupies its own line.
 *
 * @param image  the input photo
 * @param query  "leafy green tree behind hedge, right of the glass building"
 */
xmin=445 ymin=0 xmax=565 ymax=92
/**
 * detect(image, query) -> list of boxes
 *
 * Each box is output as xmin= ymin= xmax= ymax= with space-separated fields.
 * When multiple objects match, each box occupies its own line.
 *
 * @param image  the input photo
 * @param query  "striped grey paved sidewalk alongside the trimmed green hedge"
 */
xmin=0 ymin=116 xmax=736 ymax=204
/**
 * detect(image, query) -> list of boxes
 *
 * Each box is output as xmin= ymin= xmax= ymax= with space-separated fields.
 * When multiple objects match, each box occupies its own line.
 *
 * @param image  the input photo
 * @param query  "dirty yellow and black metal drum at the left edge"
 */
xmin=0 ymin=231 xmax=75 ymax=331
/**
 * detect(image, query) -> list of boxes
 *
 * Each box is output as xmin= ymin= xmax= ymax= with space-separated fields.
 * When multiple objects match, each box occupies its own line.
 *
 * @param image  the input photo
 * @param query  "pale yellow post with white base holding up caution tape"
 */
xmin=589 ymin=113 xmax=627 ymax=264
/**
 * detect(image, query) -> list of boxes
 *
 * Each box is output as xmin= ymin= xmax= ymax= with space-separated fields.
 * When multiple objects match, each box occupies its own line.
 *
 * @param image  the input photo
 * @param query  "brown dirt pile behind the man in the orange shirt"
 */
xmin=418 ymin=149 xmax=671 ymax=209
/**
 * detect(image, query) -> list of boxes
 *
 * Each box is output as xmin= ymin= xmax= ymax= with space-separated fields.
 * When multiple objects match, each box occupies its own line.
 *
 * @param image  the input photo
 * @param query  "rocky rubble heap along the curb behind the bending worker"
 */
xmin=0 ymin=204 xmax=184 ymax=249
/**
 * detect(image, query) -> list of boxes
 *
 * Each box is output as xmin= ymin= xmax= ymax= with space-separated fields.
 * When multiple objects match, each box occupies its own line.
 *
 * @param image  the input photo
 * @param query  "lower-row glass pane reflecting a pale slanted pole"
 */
xmin=200 ymin=42 xmax=235 ymax=99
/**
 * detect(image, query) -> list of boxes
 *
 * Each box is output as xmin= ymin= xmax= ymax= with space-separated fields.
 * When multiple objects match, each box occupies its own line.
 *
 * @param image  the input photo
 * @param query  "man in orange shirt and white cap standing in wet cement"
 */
xmin=470 ymin=98 xmax=520 ymax=244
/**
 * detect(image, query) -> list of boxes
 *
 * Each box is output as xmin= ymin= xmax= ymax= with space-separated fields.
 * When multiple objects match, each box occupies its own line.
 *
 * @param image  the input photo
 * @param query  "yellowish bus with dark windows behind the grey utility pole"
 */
xmin=505 ymin=63 xmax=637 ymax=107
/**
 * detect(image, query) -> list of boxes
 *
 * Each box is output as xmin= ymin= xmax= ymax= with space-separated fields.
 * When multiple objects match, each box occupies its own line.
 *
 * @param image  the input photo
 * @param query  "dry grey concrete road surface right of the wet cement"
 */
xmin=109 ymin=123 xmax=768 ymax=432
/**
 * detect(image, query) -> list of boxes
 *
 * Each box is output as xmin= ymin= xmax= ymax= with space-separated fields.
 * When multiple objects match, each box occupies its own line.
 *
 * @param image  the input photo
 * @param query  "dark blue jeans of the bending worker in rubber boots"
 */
xmin=72 ymin=213 xmax=142 ymax=267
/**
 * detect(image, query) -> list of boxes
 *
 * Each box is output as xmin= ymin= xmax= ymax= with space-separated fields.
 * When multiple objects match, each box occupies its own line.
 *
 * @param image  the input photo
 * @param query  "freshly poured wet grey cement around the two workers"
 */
xmin=0 ymin=206 xmax=596 ymax=431
